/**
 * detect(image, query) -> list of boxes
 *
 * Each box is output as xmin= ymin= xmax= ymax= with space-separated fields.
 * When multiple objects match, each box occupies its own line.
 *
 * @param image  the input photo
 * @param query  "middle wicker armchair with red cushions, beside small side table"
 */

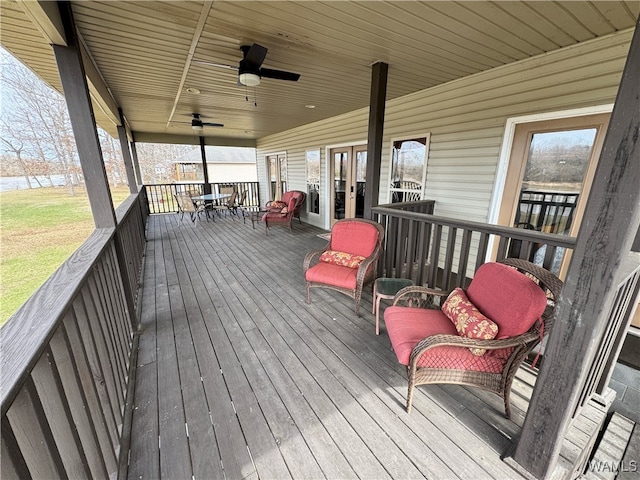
xmin=303 ymin=218 xmax=384 ymax=315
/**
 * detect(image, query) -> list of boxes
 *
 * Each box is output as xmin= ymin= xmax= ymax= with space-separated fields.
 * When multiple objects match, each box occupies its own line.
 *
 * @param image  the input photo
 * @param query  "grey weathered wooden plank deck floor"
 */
xmin=122 ymin=215 xmax=533 ymax=479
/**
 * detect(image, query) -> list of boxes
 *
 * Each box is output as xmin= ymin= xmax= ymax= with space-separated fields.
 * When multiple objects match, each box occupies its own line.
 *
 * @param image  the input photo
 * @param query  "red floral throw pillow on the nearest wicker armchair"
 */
xmin=442 ymin=287 xmax=498 ymax=356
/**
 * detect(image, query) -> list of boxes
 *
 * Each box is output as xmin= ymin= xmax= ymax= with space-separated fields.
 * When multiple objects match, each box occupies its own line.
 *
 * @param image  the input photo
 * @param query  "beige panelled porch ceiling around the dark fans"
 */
xmin=0 ymin=0 xmax=640 ymax=144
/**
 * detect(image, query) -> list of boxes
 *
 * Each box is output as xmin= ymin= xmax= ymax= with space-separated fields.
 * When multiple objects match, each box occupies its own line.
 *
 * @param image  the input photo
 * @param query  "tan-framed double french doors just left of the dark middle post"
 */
xmin=329 ymin=145 xmax=367 ymax=225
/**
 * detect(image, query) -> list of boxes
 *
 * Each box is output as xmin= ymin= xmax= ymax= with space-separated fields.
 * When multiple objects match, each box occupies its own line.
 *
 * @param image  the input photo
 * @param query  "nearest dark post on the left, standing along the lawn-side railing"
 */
xmin=53 ymin=2 xmax=116 ymax=228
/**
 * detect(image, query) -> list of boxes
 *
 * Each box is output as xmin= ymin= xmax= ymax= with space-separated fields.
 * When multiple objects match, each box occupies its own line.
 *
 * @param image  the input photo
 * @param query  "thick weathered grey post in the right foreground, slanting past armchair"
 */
xmin=513 ymin=16 xmax=640 ymax=479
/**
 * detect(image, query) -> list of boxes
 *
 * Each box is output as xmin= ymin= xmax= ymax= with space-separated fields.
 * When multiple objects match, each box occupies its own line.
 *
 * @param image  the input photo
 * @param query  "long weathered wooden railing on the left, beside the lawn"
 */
xmin=0 ymin=191 xmax=146 ymax=478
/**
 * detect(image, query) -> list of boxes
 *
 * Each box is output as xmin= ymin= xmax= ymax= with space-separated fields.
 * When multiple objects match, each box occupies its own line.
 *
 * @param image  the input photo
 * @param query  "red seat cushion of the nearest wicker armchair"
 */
xmin=384 ymin=306 xmax=512 ymax=374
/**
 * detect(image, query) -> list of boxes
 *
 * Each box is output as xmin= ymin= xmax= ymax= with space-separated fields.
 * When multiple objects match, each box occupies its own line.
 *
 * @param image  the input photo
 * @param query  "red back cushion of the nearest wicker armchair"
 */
xmin=466 ymin=262 xmax=547 ymax=338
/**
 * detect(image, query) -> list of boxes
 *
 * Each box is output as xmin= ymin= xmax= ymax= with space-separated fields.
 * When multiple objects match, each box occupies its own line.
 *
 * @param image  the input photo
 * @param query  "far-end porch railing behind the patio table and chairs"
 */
xmin=145 ymin=182 xmax=261 ymax=213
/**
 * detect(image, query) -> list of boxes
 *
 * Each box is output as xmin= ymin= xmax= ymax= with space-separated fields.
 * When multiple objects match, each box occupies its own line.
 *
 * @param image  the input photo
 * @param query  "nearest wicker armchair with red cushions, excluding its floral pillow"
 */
xmin=384 ymin=258 xmax=562 ymax=418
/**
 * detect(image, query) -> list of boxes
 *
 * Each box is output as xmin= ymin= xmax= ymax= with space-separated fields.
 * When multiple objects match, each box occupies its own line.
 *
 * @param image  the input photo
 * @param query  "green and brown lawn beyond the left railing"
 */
xmin=0 ymin=187 xmax=129 ymax=325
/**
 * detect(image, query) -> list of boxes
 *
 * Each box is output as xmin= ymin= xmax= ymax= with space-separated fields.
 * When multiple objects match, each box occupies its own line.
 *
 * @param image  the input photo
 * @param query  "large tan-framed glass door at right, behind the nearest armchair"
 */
xmin=499 ymin=114 xmax=609 ymax=274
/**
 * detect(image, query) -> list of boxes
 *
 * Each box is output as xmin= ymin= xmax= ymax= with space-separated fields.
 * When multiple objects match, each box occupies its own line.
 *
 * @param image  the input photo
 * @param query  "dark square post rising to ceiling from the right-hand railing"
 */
xmin=364 ymin=62 xmax=389 ymax=218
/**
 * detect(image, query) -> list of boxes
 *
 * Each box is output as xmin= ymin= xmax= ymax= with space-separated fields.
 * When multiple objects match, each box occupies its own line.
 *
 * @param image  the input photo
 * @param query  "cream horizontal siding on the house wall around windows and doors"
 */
xmin=257 ymin=30 xmax=632 ymax=230
